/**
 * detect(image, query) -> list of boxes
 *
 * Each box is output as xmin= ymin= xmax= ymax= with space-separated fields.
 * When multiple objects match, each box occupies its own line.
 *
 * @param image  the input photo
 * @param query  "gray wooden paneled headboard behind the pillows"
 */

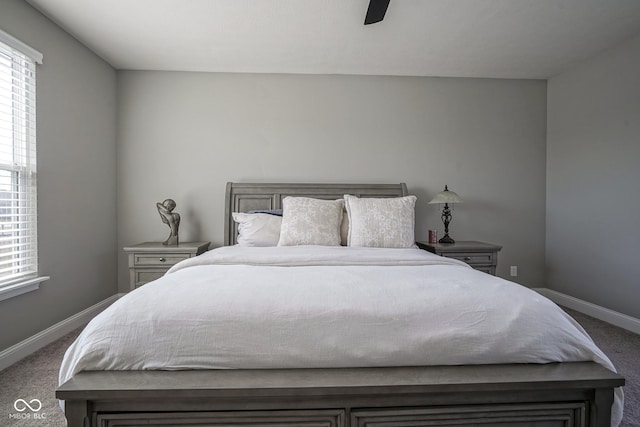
xmin=224 ymin=182 xmax=408 ymax=246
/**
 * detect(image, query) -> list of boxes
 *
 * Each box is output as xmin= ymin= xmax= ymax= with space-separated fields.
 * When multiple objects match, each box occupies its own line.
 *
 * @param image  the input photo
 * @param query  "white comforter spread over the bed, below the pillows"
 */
xmin=60 ymin=246 xmax=622 ymax=425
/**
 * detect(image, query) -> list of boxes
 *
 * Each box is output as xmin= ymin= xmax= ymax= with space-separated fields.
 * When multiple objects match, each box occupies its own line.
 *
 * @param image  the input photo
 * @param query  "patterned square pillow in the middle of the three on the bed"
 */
xmin=278 ymin=196 xmax=344 ymax=246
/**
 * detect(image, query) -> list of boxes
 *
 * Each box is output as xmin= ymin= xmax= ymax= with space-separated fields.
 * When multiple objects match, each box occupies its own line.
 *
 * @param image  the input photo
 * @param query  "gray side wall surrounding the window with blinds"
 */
xmin=0 ymin=0 xmax=117 ymax=350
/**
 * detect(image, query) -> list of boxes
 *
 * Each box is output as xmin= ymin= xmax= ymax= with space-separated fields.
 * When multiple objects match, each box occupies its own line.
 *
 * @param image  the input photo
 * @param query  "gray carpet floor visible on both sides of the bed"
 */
xmin=0 ymin=310 xmax=640 ymax=427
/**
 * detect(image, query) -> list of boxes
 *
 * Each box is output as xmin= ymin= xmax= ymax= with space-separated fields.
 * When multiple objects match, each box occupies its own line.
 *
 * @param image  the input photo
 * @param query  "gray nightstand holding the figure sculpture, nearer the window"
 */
xmin=124 ymin=242 xmax=211 ymax=290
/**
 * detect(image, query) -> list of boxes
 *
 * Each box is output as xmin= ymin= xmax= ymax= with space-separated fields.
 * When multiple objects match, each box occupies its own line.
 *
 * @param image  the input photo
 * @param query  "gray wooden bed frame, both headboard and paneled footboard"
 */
xmin=56 ymin=183 xmax=624 ymax=427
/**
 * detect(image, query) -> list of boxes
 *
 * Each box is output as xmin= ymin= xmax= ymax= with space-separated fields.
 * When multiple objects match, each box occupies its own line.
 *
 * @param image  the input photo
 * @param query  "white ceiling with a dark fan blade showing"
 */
xmin=22 ymin=0 xmax=640 ymax=78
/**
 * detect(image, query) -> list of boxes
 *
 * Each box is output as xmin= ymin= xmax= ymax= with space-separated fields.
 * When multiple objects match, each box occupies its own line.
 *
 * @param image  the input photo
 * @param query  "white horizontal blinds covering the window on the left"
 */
xmin=0 ymin=32 xmax=42 ymax=288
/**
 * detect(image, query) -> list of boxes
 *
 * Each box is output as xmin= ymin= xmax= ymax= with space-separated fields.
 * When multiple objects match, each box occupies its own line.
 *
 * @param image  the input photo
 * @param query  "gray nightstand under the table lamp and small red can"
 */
xmin=416 ymin=241 xmax=502 ymax=276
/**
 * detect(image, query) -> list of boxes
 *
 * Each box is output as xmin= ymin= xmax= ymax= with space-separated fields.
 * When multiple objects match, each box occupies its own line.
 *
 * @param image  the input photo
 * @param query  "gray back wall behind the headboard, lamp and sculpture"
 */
xmin=117 ymin=71 xmax=546 ymax=291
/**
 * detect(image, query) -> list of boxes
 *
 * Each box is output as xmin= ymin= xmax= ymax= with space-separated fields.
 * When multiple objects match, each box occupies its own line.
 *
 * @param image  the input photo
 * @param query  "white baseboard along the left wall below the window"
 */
xmin=0 ymin=294 xmax=123 ymax=371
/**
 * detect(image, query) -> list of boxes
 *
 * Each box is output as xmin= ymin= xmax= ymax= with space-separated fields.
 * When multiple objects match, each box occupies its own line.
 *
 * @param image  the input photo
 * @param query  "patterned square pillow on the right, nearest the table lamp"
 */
xmin=344 ymin=194 xmax=416 ymax=248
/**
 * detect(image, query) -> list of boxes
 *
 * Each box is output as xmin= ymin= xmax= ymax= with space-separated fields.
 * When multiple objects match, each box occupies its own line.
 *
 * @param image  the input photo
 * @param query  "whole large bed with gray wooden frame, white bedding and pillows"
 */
xmin=56 ymin=183 xmax=624 ymax=427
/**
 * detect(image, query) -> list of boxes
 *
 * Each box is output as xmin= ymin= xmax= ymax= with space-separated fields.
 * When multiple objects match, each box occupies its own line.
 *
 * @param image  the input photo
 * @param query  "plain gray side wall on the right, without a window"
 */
xmin=546 ymin=31 xmax=640 ymax=318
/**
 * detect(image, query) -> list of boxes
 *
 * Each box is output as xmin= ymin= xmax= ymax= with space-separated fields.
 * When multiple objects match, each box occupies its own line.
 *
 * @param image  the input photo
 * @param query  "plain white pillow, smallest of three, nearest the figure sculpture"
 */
xmin=231 ymin=212 xmax=282 ymax=246
